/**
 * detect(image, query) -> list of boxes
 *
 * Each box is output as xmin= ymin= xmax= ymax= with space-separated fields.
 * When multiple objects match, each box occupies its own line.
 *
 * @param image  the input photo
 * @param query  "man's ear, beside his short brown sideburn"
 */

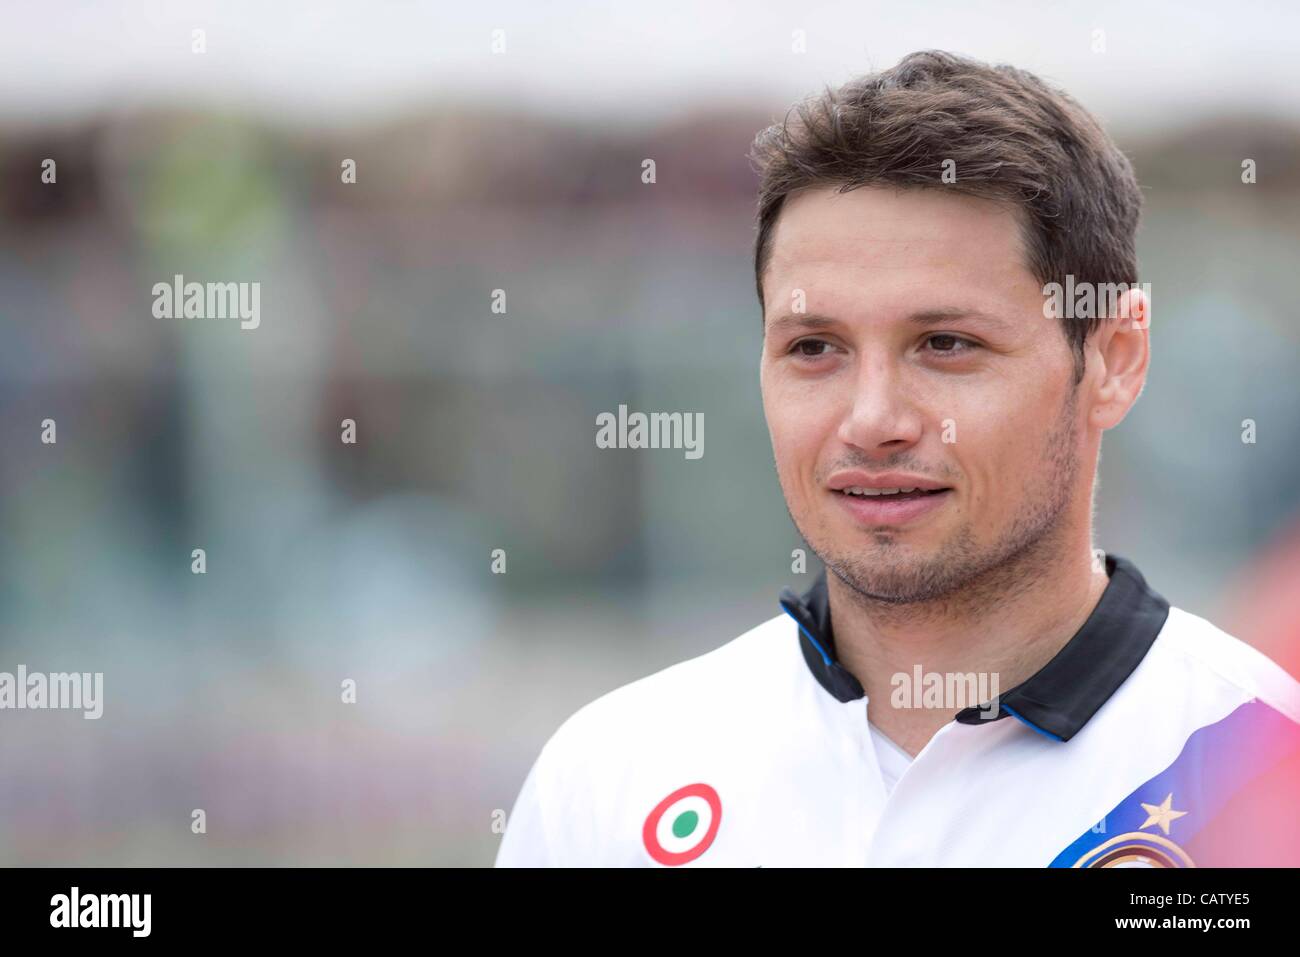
xmin=1088 ymin=286 xmax=1151 ymax=429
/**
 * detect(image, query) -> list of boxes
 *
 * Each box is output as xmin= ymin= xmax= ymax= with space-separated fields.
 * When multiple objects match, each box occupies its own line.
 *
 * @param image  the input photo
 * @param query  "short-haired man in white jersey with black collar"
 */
xmin=497 ymin=52 xmax=1300 ymax=867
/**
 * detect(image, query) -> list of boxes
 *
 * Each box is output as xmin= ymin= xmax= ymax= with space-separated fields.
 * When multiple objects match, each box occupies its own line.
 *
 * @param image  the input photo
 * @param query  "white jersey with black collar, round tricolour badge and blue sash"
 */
xmin=497 ymin=555 xmax=1300 ymax=867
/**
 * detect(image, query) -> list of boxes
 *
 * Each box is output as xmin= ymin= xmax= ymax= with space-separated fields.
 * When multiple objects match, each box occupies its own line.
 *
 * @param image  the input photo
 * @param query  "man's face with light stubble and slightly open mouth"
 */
xmin=762 ymin=187 xmax=1095 ymax=603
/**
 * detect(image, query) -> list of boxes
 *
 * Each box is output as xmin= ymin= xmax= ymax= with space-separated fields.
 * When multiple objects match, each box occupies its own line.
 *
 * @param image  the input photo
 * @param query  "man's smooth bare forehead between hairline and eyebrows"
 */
xmin=763 ymin=186 xmax=1040 ymax=317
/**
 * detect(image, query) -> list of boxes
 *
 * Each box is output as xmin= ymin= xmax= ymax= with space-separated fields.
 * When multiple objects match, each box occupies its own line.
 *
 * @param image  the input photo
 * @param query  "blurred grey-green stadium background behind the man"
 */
xmin=0 ymin=0 xmax=1300 ymax=866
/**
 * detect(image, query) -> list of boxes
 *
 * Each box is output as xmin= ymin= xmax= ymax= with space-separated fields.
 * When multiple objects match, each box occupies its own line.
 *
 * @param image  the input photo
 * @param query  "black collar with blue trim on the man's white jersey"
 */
xmin=781 ymin=555 xmax=1169 ymax=741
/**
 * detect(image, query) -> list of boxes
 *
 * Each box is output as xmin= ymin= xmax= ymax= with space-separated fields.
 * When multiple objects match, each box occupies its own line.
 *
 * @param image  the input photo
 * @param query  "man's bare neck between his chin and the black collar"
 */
xmin=827 ymin=534 xmax=1109 ymax=755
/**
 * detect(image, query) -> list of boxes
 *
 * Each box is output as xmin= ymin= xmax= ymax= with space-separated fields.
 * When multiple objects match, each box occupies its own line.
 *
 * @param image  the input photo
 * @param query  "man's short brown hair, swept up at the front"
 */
xmin=750 ymin=51 xmax=1141 ymax=382
